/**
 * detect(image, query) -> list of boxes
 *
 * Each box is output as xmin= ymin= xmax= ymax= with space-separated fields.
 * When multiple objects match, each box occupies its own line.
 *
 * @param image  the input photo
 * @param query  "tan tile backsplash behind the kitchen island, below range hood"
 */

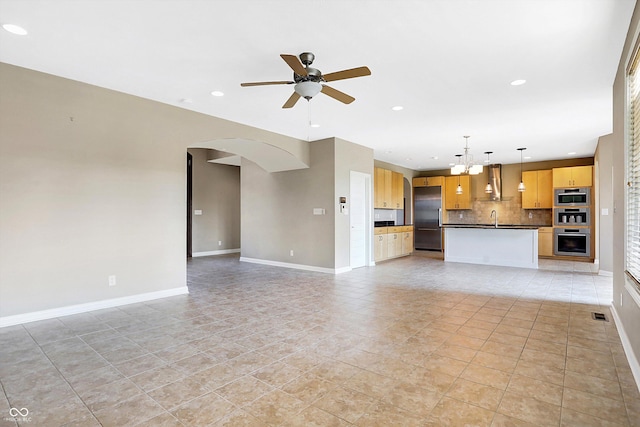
xmin=446 ymin=197 xmax=553 ymax=227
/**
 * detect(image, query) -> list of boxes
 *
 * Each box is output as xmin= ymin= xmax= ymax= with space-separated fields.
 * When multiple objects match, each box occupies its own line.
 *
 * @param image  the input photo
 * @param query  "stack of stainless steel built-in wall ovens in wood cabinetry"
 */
xmin=553 ymin=188 xmax=591 ymax=258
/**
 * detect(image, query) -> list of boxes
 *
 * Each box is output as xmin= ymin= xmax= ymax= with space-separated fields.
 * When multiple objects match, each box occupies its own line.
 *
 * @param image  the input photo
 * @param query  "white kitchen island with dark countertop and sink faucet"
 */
xmin=443 ymin=224 xmax=538 ymax=268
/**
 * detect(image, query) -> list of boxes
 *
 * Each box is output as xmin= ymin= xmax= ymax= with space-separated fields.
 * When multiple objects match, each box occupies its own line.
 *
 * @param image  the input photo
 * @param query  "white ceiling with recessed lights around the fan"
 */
xmin=0 ymin=0 xmax=635 ymax=170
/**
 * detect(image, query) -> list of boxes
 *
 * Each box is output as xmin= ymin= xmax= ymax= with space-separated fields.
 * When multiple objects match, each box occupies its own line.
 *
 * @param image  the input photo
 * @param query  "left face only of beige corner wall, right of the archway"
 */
xmin=240 ymin=140 xmax=335 ymax=268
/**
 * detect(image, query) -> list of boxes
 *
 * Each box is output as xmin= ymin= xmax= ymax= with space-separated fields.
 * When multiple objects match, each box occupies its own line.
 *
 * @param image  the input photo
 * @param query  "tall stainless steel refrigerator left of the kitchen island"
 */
xmin=413 ymin=186 xmax=442 ymax=251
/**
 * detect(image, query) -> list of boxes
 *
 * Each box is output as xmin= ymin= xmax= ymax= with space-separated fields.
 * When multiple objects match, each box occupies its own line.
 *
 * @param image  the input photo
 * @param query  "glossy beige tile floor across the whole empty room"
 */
xmin=0 ymin=256 xmax=640 ymax=427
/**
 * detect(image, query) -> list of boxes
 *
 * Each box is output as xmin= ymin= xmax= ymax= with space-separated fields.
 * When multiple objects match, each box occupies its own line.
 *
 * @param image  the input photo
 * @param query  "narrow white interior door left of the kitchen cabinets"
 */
xmin=347 ymin=171 xmax=369 ymax=268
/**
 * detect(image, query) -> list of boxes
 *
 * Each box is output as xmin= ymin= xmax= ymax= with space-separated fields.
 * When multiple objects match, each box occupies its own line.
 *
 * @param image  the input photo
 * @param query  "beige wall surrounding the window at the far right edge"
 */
xmin=601 ymin=1 xmax=640 ymax=372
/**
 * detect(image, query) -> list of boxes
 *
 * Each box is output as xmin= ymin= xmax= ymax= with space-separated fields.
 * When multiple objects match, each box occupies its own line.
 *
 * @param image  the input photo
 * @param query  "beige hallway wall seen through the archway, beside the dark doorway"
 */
xmin=188 ymin=148 xmax=240 ymax=254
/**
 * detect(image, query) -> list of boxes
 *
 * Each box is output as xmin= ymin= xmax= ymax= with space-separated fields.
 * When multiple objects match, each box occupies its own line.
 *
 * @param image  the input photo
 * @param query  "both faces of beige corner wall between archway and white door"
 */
xmin=241 ymin=138 xmax=373 ymax=270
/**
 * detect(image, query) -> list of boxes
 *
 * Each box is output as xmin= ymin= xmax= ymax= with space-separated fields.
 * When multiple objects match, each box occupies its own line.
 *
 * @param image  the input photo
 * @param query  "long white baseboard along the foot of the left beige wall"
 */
xmin=0 ymin=286 xmax=189 ymax=328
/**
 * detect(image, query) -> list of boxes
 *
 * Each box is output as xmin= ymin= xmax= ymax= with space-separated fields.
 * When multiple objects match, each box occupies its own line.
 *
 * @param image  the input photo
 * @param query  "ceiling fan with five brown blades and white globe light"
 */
xmin=240 ymin=52 xmax=371 ymax=108
